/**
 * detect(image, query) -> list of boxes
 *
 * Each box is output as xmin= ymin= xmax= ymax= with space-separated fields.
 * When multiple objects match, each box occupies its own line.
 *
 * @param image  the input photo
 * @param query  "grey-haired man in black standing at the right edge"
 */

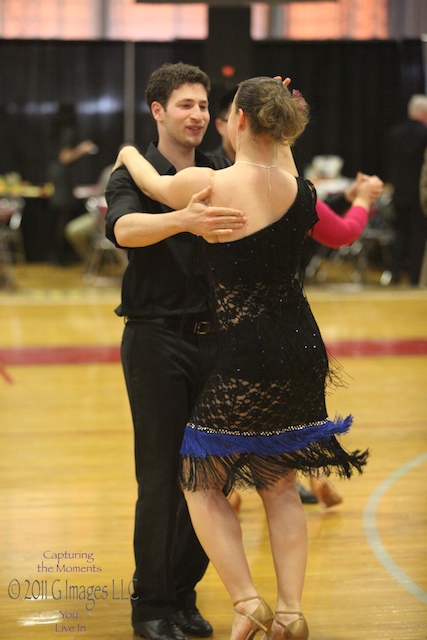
xmin=387 ymin=94 xmax=427 ymax=285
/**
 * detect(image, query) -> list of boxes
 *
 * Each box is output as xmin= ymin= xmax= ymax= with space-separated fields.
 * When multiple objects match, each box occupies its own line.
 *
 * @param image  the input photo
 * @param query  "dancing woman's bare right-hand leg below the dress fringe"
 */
xmin=259 ymin=474 xmax=307 ymax=637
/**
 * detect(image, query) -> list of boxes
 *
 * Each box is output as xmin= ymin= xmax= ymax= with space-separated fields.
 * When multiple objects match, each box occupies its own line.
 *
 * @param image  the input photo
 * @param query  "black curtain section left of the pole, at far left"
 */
xmin=0 ymin=40 xmax=124 ymax=184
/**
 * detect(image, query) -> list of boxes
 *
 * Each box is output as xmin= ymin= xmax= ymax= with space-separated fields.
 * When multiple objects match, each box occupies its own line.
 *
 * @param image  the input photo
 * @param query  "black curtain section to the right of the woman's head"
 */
xmin=256 ymin=41 xmax=418 ymax=176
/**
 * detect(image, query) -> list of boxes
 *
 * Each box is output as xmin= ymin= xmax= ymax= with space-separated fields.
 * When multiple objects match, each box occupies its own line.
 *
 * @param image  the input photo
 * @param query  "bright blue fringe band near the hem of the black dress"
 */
xmin=181 ymin=415 xmax=353 ymax=458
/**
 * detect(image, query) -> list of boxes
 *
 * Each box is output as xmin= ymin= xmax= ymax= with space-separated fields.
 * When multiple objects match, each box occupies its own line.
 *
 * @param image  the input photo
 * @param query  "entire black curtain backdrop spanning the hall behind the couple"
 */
xmin=0 ymin=40 xmax=425 ymax=195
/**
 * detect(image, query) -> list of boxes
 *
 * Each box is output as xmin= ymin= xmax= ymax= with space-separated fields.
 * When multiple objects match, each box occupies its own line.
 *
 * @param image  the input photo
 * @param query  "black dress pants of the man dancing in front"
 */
xmin=121 ymin=321 xmax=216 ymax=622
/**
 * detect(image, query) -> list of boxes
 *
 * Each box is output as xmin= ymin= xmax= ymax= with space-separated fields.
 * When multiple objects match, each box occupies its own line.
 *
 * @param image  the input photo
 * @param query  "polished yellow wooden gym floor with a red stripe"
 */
xmin=0 ymin=265 xmax=427 ymax=640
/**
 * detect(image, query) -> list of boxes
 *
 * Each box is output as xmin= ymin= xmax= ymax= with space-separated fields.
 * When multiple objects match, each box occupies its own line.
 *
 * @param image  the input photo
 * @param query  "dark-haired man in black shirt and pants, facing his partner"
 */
xmin=106 ymin=63 xmax=245 ymax=640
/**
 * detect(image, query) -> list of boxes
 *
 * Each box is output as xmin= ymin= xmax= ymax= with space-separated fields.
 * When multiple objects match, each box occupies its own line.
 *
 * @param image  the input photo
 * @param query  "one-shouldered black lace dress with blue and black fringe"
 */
xmin=181 ymin=178 xmax=367 ymax=492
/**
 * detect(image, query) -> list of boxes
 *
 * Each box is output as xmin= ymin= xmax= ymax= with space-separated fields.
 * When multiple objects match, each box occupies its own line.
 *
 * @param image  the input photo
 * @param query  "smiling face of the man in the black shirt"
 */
xmin=152 ymin=84 xmax=210 ymax=148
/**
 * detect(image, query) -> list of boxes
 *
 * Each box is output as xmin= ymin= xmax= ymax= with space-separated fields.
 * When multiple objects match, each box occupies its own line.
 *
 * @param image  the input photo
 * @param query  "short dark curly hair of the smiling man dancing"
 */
xmin=145 ymin=62 xmax=211 ymax=108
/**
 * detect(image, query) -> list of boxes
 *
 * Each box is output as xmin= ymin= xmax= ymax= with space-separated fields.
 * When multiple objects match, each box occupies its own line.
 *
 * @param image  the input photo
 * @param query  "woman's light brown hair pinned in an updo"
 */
xmin=234 ymin=76 xmax=308 ymax=144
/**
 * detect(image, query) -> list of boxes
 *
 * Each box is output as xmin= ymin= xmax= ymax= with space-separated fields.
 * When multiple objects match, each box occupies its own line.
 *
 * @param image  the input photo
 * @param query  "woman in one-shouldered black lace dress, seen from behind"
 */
xmin=113 ymin=77 xmax=367 ymax=640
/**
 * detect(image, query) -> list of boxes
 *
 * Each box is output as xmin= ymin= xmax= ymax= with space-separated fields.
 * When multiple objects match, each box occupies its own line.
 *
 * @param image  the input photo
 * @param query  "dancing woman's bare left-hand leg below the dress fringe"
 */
xmin=185 ymin=489 xmax=270 ymax=640
